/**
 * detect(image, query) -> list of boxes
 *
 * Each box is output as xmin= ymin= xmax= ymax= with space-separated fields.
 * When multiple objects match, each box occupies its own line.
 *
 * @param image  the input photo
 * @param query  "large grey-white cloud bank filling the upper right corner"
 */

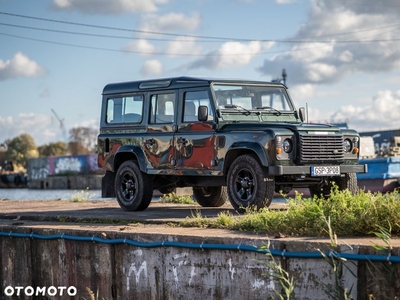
xmin=258 ymin=0 xmax=400 ymax=84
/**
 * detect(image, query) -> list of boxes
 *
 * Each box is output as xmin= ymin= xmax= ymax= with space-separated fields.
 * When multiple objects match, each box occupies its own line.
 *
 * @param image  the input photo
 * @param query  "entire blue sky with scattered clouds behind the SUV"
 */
xmin=0 ymin=0 xmax=400 ymax=145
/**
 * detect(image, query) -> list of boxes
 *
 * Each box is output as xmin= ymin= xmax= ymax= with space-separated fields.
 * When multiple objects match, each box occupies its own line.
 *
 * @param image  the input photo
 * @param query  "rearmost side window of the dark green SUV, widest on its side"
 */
xmin=106 ymin=95 xmax=143 ymax=124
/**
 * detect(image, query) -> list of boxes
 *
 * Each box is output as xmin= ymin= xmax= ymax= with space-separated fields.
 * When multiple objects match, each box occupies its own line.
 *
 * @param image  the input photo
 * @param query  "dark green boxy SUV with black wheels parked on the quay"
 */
xmin=98 ymin=77 xmax=366 ymax=212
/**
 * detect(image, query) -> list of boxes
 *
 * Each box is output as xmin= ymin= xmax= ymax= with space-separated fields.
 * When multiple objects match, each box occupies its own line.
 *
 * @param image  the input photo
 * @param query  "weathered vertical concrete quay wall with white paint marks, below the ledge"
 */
xmin=0 ymin=226 xmax=400 ymax=300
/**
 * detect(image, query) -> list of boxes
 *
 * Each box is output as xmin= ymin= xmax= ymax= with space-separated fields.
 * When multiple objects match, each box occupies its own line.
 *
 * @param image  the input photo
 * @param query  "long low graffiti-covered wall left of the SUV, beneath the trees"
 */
xmin=27 ymin=154 xmax=103 ymax=179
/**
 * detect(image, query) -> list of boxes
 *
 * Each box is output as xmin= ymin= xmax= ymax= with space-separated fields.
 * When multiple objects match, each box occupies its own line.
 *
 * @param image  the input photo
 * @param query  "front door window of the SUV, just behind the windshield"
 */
xmin=183 ymin=91 xmax=213 ymax=122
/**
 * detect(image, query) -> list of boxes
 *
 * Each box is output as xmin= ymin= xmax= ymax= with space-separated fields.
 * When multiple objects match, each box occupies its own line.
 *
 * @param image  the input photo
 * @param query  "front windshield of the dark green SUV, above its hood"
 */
xmin=213 ymin=84 xmax=294 ymax=113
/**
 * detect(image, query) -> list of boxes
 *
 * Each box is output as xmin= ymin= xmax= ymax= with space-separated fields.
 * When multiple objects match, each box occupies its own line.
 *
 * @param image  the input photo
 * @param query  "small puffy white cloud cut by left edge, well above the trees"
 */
xmin=0 ymin=52 xmax=46 ymax=80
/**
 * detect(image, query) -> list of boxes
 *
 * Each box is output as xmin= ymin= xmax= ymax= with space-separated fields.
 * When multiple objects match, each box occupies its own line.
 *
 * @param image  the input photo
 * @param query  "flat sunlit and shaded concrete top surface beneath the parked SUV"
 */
xmin=0 ymin=200 xmax=400 ymax=247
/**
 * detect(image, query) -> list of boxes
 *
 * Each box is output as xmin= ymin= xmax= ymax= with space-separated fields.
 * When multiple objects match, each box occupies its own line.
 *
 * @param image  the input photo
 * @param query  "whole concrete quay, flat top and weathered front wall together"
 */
xmin=0 ymin=201 xmax=400 ymax=300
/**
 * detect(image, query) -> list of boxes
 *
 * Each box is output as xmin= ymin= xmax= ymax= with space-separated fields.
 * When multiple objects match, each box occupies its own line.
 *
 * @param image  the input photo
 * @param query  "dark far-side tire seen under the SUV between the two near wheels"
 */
xmin=193 ymin=186 xmax=228 ymax=207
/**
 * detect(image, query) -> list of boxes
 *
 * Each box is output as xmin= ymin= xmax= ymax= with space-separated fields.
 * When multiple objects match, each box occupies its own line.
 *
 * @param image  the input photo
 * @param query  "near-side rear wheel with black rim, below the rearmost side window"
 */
xmin=115 ymin=160 xmax=153 ymax=211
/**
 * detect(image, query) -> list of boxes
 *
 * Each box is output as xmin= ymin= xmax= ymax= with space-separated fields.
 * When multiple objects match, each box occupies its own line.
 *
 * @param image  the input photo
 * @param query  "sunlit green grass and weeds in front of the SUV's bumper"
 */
xmin=180 ymin=187 xmax=400 ymax=236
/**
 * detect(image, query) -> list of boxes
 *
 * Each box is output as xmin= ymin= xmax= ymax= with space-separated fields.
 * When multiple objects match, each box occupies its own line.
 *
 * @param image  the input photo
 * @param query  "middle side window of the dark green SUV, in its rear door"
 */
xmin=150 ymin=93 xmax=175 ymax=124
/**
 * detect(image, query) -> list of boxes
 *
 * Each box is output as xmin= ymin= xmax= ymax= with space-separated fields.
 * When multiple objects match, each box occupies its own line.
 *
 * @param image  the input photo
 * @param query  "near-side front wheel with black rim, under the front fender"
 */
xmin=227 ymin=154 xmax=275 ymax=213
